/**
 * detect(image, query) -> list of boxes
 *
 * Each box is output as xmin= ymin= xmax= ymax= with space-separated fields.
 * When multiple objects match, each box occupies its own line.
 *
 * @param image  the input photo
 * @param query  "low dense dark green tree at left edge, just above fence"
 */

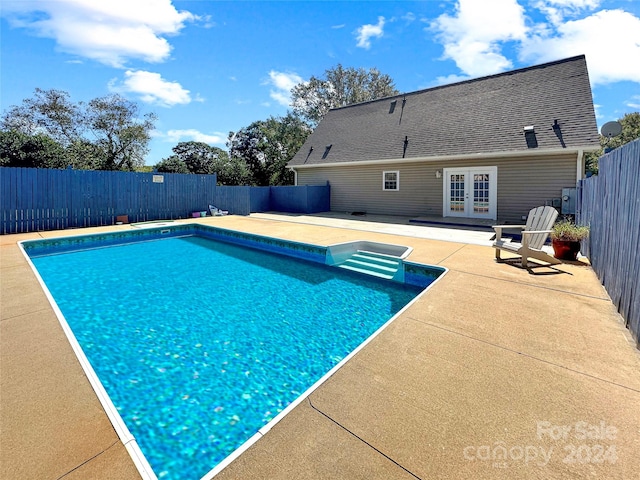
xmin=0 ymin=130 xmax=68 ymax=168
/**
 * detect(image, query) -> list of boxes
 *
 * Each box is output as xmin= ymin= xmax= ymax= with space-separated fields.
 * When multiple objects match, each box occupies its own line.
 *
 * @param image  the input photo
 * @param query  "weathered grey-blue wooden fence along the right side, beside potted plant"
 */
xmin=577 ymin=139 xmax=640 ymax=347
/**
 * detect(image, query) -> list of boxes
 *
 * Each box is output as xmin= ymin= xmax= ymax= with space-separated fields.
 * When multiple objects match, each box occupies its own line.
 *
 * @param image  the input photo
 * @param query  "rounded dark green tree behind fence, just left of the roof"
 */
xmin=227 ymin=113 xmax=311 ymax=186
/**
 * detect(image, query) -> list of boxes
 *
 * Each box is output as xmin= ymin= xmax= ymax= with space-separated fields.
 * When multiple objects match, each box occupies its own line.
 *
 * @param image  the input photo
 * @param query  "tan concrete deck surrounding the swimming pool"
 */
xmin=0 ymin=215 xmax=640 ymax=480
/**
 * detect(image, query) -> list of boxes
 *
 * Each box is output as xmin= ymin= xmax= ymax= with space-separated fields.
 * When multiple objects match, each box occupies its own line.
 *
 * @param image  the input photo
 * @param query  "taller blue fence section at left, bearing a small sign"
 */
xmin=0 ymin=167 xmax=216 ymax=234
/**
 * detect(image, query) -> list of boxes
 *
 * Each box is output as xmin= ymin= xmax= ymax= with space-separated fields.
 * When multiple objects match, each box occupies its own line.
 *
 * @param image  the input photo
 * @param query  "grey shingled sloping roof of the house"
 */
xmin=288 ymin=55 xmax=599 ymax=167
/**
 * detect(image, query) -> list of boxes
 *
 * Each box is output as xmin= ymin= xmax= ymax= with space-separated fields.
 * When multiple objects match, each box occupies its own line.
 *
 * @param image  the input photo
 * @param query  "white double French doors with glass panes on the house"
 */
xmin=442 ymin=167 xmax=498 ymax=220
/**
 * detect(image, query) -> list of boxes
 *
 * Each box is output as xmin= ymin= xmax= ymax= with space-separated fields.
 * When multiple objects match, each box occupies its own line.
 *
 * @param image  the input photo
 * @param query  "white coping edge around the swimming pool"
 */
xmin=17 ymin=222 xmax=449 ymax=480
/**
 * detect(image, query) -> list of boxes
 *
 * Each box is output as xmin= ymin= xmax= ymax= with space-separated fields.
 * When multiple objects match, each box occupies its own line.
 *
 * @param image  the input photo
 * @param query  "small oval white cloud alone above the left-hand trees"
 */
xmin=109 ymin=70 xmax=192 ymax=107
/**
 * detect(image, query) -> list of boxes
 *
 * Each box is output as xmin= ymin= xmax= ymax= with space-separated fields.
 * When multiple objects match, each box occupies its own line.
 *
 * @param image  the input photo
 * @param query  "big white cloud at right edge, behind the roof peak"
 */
xmin=520 ymin=10 xmax=640 ymax=85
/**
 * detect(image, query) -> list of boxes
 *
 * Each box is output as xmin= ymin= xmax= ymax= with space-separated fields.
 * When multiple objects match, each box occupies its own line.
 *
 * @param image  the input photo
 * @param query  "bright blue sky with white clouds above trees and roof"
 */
xmin=0 ymin=0 xmax=640 ymax=165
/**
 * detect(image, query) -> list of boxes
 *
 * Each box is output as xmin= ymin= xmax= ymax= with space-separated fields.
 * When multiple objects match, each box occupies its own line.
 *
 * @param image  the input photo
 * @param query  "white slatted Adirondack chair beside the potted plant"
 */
xmin=493 ymin=206 xmax=561 ymax=268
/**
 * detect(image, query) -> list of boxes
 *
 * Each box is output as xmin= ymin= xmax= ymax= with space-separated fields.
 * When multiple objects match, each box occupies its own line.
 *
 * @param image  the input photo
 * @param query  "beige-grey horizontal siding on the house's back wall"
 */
xmin=298 ymin=155 xmax=577 ymax=222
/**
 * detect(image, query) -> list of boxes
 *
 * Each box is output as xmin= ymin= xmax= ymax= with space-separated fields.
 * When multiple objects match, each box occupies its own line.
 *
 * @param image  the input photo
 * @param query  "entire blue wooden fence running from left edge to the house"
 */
xmin=0 ymin=167 xmax=330 ymax=234
